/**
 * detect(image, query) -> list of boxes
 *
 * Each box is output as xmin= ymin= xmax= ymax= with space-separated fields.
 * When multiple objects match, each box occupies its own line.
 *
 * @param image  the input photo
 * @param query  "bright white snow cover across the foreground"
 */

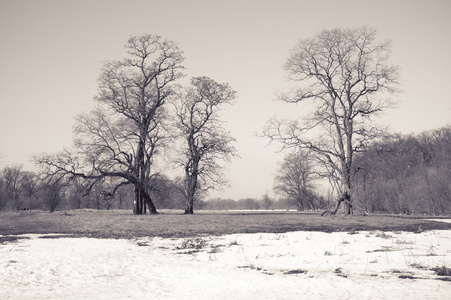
xmin=0 ymin=230 xmax=451 ymax=300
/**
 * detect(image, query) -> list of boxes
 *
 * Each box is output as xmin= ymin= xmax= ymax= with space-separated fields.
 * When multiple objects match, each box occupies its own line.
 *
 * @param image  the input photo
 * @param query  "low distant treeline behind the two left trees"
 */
xmin=0 ymin=165 xmax=198 ymax=212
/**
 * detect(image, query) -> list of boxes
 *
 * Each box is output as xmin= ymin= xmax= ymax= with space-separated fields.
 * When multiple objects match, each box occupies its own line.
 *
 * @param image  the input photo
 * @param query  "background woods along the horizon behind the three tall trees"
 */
xmin=0 ymin=126 xmax=451 ymax=215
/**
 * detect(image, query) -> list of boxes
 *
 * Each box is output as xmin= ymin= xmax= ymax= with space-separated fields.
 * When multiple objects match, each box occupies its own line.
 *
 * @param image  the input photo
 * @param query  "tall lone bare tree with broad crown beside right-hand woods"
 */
xmin=264 ymin=26 xmax=399 ymax=214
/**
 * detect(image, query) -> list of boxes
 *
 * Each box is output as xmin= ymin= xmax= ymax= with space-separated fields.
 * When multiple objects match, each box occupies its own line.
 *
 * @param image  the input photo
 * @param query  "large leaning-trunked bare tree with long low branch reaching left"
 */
xmin=35 ymin=35 xmax=184 ymax=214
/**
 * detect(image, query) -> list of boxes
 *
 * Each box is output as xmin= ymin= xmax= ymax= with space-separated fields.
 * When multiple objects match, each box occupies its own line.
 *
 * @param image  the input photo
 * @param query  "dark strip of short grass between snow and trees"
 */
xmin=0 ymin=210 xmax=451 ymax=238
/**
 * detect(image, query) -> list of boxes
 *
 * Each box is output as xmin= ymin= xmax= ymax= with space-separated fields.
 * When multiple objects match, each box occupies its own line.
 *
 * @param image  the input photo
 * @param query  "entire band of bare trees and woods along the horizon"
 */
xmin=0 ymin=26 xmax=451 ymax=214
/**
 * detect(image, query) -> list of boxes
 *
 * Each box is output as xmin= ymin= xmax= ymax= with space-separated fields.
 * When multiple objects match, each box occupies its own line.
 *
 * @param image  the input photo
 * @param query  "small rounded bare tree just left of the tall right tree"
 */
xmin=274 ymin=150 xmax=315 ymax=210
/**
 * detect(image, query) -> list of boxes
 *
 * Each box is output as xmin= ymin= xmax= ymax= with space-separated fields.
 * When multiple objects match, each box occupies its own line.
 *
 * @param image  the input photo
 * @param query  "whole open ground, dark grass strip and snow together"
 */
xmin=0 ymin=210 xmax=451 ymax=300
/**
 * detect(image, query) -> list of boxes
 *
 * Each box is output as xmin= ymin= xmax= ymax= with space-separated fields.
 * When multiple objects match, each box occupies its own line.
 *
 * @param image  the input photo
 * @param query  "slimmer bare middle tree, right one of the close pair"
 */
xmin=173 ymin=77 xmax=236 ymax=214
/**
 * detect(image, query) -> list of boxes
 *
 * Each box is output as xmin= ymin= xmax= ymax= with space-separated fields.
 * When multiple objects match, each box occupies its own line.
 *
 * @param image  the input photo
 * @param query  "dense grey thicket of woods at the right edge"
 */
xmin=353 ymin=126 xmax=451 ymax=215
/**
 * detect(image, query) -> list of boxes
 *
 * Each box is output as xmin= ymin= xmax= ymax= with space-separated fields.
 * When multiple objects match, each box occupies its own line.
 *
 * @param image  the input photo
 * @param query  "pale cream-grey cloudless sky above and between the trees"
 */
xmin=0 ymin=0 xmax=451 ymax=199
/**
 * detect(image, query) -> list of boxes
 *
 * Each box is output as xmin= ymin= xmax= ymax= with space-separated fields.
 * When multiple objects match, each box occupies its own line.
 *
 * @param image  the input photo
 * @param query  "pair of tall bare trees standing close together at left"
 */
xmin=35 ymin=35 xmax=235 ymax=214
